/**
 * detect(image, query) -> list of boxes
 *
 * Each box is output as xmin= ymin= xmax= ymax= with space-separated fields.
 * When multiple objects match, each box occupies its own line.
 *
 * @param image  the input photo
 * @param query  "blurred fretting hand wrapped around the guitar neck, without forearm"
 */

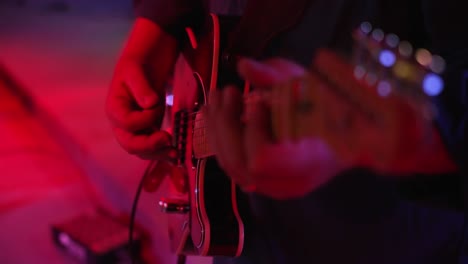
xmin=207 ymin=59 xmax=344 ymax=199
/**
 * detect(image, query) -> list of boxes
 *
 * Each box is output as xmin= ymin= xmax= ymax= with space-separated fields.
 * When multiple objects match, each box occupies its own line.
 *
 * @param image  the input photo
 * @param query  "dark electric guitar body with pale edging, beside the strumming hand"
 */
xmin=168 ymin=14 xmax=244 ymax=256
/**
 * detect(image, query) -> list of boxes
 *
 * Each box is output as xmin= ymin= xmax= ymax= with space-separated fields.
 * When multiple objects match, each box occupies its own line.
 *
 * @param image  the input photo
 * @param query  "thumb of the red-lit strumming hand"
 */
xmin=125 ymin=64 xmax=165 ymax=109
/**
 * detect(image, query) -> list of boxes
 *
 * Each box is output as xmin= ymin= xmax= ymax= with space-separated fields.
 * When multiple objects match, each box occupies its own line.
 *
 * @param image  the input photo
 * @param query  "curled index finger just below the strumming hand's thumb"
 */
xmin=106 ymin=87 xmax=165 ymax=132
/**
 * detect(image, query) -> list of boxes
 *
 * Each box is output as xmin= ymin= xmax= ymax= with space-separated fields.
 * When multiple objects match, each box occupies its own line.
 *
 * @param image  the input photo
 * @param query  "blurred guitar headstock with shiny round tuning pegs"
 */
xmin=350 ymin=22 xmax=445 ymax=118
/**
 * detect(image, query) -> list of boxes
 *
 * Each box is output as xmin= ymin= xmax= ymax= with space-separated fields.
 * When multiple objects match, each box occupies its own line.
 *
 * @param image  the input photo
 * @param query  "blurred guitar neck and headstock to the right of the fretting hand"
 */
xmin=272 ymin=22 xmax=445 ymax=170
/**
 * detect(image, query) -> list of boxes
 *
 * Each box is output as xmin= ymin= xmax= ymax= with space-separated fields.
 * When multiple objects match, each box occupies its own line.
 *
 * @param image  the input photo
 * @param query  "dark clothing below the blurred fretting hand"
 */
xmin=215 ymin=171 xmax=466 ymax=264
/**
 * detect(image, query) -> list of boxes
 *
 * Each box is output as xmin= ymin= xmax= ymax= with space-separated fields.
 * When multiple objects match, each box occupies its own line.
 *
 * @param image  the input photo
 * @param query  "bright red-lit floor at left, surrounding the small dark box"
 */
xmin=0 ymin=0 xmax=211 ymax=264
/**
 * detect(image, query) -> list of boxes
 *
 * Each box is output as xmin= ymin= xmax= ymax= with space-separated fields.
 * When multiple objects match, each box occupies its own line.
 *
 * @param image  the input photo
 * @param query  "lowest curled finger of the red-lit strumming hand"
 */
xmin=114 ymin=128 xmax=171 ymax=157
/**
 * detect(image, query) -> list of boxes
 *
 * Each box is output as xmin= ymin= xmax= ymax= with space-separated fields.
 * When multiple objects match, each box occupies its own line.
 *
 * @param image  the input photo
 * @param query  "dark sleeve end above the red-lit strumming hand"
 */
xmin=137 ymin=0 xmax=207 ymax=38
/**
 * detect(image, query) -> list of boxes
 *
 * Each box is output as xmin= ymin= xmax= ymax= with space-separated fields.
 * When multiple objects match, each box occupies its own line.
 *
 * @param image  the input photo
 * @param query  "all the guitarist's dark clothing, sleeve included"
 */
xmin=135 ymin=0 xmax=468 ymax=264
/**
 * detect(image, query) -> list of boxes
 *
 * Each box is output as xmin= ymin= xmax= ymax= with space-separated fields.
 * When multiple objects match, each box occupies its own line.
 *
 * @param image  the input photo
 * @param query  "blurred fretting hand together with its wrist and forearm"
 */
xmin=207 ymin=55 xmax=457 ymax=199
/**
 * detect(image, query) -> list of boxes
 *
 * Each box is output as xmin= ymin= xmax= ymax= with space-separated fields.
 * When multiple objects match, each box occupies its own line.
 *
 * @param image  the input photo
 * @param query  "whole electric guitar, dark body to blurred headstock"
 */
xmin=160 ymin=14 xmax=444 ymax=256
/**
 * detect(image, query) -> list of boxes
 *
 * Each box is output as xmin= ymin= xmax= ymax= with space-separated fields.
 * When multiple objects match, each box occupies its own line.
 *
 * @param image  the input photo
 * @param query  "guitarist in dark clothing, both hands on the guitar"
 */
xmin=107 ymin=0 xmax=468 ymax=264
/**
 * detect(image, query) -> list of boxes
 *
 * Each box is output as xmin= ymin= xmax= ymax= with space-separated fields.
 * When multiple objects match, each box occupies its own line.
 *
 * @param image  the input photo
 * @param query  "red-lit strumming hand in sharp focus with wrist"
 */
xmin=106 ymin=18 xmax=177 ymax=159
